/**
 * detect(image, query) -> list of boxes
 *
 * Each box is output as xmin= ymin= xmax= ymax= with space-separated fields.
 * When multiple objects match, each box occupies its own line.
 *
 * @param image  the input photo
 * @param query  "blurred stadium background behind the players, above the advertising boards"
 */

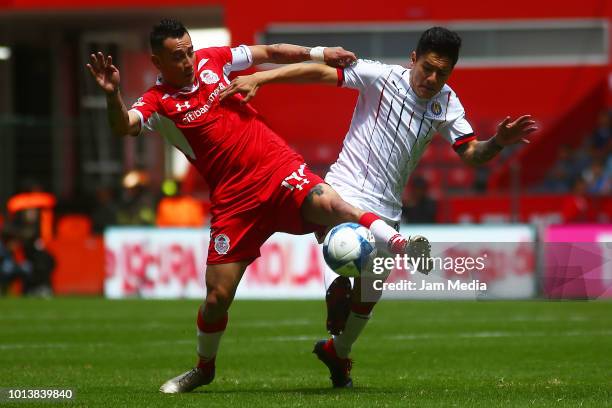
xmin=0 ymin=0 xmax=612 ymax=294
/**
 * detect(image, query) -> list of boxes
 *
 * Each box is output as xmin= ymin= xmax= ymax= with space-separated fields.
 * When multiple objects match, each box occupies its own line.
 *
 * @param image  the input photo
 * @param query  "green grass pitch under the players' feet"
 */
xmin=0 ymin=298 xmax=612 ymax=408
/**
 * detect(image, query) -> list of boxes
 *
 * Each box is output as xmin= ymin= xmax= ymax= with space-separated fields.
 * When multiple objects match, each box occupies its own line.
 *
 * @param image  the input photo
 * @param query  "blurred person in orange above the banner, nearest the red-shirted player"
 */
xmin=157 ymin=180 xmax=205 ymax=227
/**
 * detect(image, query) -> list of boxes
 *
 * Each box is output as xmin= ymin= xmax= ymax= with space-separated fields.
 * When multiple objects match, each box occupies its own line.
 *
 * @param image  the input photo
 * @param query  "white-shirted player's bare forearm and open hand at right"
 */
xmin=457 ymin=115 xmax=538 ymax=166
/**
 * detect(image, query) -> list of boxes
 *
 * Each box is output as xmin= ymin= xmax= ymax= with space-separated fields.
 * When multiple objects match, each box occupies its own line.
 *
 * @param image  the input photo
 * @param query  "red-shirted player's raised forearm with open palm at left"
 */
xmin=87 ymin=52 xmax=140 ymax=136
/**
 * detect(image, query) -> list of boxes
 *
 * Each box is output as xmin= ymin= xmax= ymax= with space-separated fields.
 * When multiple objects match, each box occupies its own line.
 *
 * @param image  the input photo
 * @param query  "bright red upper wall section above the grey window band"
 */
xmin=225 ymin=0 xmax=612 ymax=44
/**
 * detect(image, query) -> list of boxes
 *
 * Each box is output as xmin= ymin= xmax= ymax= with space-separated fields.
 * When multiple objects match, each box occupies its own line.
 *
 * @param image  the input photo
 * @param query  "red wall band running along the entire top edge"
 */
xmin=0 ymin=0 xmax=612 ymax=29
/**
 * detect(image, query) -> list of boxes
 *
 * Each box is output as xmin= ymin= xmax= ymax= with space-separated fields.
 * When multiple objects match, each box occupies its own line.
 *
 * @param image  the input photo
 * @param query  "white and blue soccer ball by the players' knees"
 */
xmin=323 ymin=222 xmax=376 ymax=278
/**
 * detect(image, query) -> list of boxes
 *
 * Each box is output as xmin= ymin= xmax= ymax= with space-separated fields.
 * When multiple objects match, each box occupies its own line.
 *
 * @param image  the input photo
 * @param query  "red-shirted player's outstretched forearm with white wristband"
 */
xmin=249 ymin=44 xmax=357 ymax=67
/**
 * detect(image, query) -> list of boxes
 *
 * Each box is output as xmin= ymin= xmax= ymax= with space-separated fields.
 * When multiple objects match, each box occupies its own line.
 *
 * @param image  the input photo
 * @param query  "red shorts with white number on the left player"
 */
xmin=207 ymin=164 xmax=325 ymax=265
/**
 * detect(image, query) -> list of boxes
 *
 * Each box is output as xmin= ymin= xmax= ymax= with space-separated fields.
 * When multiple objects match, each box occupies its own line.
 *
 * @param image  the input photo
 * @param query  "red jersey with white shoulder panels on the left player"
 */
xmin=131 ymin=46 xmax=304 ymax=208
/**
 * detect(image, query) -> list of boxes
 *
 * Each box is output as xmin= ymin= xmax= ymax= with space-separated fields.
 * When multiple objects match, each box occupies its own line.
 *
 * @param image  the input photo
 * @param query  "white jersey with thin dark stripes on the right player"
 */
xmin=325 ymin=60 xmax=475 ymax=222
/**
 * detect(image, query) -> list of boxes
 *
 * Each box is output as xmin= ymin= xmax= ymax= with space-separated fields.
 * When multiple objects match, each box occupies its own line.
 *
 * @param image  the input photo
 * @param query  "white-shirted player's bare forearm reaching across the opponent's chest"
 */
xmin=220 ymin=64 xmax=338 ymax=103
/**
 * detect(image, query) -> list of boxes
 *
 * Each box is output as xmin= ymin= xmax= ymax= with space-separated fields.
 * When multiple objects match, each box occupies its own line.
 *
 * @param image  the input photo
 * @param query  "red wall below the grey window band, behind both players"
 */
xmin=247 ymin=67 xmax=608 ymax=158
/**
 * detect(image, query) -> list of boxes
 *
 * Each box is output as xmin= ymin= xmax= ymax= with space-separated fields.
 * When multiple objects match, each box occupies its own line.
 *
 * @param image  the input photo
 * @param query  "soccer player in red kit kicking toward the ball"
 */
xmin=87 ymin=19 xmax=426 ymax=393
